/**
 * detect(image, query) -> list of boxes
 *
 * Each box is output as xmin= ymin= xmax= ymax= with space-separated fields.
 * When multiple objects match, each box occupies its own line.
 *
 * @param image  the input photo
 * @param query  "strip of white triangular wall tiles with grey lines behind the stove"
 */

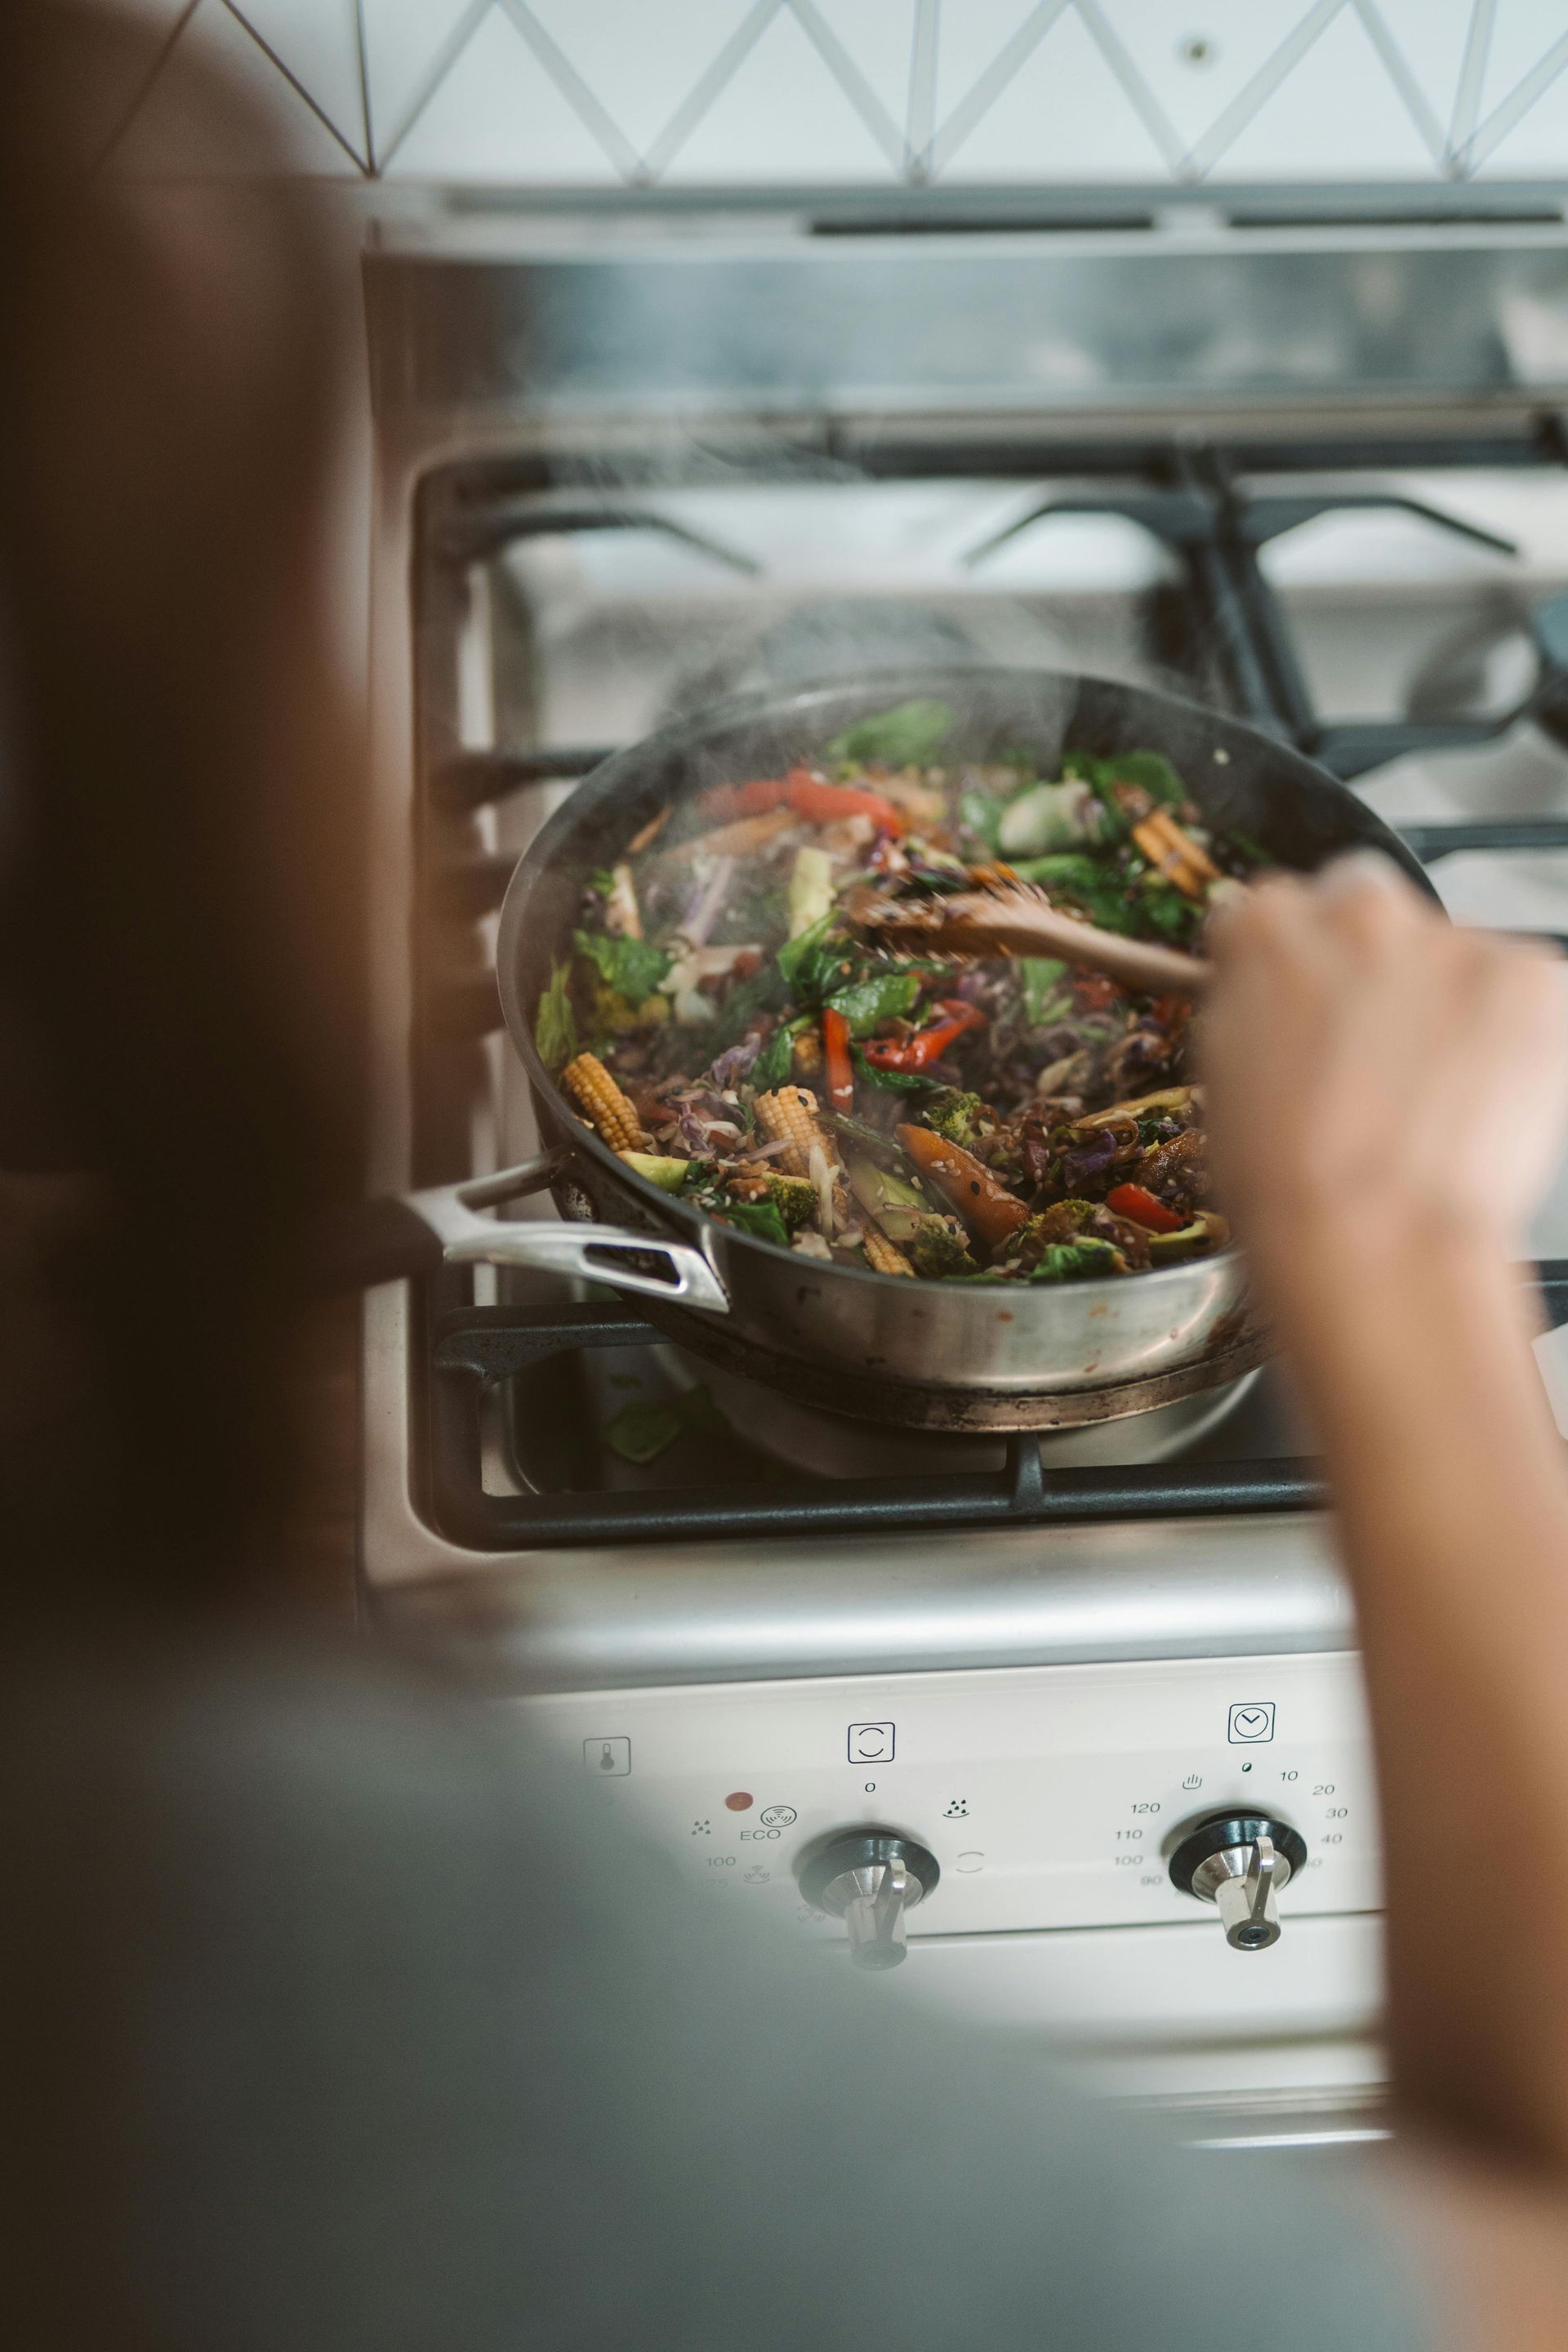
xmin=91 ymin=0 xmax=1568 ymax=188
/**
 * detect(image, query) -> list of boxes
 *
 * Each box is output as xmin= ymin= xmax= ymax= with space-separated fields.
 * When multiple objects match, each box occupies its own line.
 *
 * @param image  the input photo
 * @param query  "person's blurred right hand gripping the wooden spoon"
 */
xmin=1199 ymin=853 xmax=1568 ymax=1286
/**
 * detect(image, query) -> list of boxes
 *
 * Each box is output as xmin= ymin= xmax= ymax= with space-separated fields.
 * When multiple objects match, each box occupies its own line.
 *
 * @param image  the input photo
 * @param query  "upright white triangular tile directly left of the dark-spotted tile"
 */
xmin=938 ymin=14 xmax=1169 ymax=184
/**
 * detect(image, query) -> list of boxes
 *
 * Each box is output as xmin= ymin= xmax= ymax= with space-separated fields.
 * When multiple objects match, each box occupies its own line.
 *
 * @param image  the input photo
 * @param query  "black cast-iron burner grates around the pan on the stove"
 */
xmin=412 ymin=412 xmax=1568 ymax=1550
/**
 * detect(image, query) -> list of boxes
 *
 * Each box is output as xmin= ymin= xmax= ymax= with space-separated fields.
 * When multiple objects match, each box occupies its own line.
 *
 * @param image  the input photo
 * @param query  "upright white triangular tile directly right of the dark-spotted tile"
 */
xmin=1213 ymin=10 xmax=1432 ymax=181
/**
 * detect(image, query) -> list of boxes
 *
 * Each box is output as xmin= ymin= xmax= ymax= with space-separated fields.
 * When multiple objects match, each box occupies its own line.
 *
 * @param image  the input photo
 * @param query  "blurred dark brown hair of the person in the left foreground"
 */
xmin=0 ymin=0 xmax=364 ymax=1592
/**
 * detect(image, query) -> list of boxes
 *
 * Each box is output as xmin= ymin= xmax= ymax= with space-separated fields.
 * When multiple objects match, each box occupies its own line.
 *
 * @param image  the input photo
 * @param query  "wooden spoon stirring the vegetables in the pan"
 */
xmin=853 ymin=882 xmax=1210 ymax=997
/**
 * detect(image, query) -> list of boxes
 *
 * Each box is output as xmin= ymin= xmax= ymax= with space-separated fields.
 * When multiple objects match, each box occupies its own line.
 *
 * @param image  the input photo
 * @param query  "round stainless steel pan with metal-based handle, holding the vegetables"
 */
xmin=371 ymin=668 xmax=1427 ymax=1428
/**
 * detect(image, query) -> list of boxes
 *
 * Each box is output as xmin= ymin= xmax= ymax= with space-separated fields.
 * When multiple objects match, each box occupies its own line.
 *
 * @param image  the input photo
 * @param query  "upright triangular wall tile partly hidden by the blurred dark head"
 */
xmin=108 ymin=0 xmax=359 ymax=179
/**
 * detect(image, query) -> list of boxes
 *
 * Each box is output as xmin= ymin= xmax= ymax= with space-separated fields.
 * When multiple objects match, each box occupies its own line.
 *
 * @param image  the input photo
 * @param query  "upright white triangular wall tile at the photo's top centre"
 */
xmin=661 ymin=10 xmax=898 ymax=186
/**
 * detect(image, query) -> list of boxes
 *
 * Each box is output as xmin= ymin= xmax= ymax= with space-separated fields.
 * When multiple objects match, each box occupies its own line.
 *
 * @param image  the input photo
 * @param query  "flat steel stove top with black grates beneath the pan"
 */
xmin=364 ymin=257 xmax=1568 ymax=1673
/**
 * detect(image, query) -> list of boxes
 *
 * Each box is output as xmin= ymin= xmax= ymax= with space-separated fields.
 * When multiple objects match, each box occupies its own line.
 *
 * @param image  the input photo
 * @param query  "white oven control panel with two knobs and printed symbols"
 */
xmin=517 ymin=1651 xmax=1378 ymax=1938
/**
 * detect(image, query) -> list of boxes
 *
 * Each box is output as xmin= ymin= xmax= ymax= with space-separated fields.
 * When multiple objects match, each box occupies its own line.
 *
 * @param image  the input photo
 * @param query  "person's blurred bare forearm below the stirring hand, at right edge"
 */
xmin=1276 ymin=1245 xmax=1568 ymax=2178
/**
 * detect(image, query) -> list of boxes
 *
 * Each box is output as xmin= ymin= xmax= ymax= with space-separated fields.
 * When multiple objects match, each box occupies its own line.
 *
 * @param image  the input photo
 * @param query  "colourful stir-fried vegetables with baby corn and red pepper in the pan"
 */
xmin=536 ymin=701 xmax=1263 ymax=1282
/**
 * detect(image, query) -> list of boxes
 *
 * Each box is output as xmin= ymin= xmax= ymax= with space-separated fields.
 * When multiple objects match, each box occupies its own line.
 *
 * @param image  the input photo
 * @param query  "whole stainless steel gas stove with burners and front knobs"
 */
xmin=362 ymin=221 xmax=1568 ymax=2143
